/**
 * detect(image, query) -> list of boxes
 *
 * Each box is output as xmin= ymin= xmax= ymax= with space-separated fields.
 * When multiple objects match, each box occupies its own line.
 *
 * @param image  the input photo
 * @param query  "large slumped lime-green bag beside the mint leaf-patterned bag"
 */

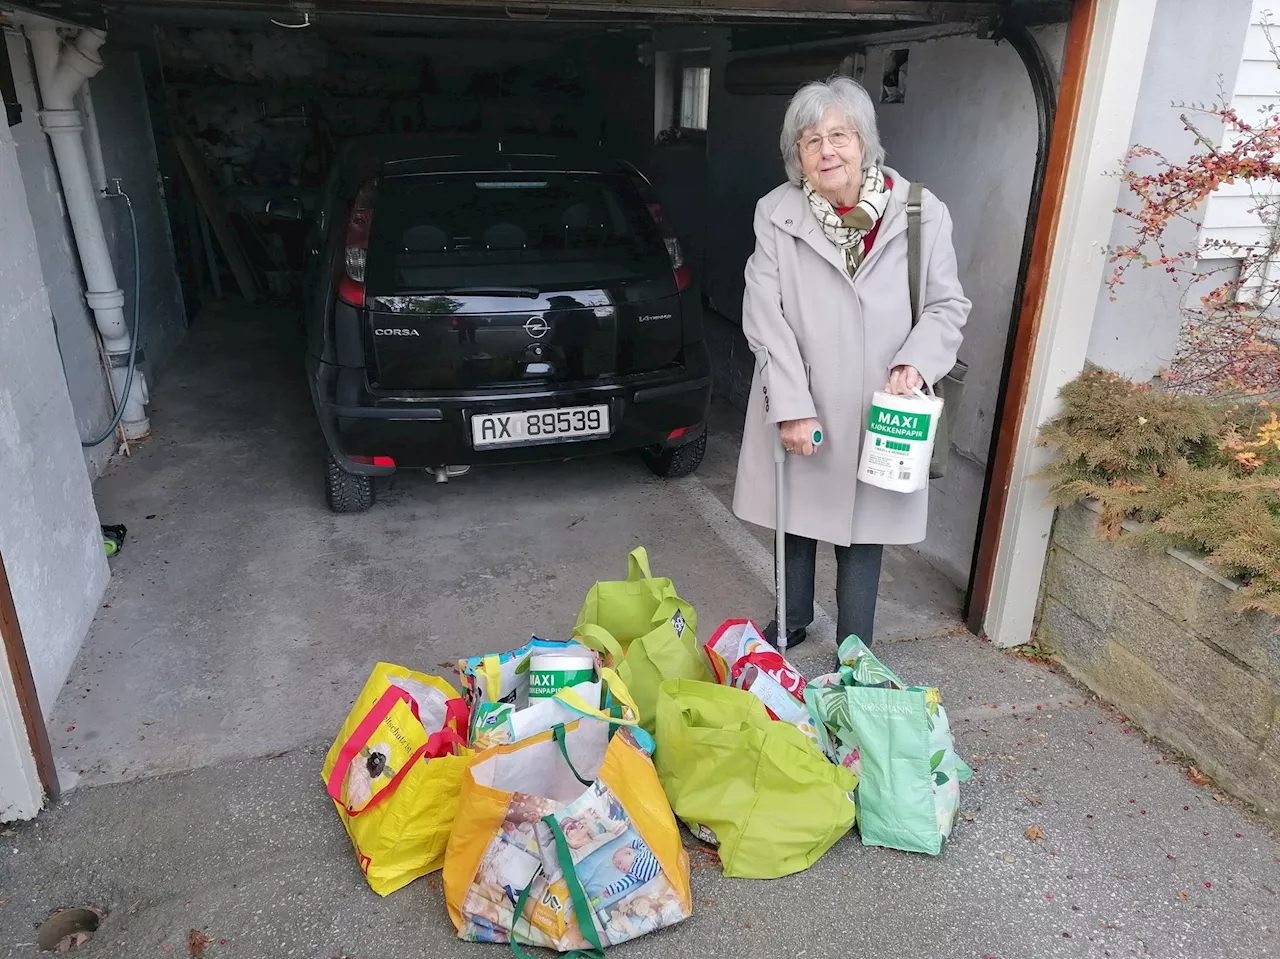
xmin=654 ymin=680 xmax=858 ymax=880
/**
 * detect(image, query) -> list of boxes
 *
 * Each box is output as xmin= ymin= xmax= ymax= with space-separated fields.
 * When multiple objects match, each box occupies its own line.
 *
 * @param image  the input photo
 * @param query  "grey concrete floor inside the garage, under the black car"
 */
xmin=51 ymin=306 xmax=960 ymax=785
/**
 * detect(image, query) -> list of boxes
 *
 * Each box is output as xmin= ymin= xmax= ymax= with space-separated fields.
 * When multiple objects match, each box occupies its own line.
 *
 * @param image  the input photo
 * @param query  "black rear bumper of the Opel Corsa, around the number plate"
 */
xmin=307 ymin=344 xmax=712 ymax=476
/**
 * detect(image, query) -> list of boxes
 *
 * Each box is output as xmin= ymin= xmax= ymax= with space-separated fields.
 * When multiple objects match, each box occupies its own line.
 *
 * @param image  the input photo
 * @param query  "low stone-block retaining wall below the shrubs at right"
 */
xmin=1037 ymin=506 xmax=1280 ymax=819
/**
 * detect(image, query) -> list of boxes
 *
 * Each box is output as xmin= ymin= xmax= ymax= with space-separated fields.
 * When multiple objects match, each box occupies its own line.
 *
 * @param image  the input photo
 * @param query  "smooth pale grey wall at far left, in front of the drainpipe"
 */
xmin=0 ymin=108 xmax=108 ymax=716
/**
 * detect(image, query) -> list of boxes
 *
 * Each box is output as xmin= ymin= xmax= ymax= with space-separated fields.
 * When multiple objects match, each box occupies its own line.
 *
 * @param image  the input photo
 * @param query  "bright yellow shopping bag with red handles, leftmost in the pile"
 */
xmin=323 ymin=663 xmax=472 ymax=896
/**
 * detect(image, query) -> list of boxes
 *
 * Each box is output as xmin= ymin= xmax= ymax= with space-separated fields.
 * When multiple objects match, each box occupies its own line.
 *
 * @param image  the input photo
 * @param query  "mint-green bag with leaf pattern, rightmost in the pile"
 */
xmin=805 ymin=636 xmax=973 ymax=855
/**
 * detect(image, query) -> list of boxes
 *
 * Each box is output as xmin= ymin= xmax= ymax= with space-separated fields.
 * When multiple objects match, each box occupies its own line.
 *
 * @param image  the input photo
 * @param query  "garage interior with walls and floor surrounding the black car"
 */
xmin=9 ymin=0 xmax=1069 ymax=784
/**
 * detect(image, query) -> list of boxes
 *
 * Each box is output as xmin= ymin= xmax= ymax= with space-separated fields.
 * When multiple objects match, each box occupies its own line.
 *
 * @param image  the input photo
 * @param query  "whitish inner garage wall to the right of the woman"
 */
xmin=867 ymin=27 xmax=1066 ymax=583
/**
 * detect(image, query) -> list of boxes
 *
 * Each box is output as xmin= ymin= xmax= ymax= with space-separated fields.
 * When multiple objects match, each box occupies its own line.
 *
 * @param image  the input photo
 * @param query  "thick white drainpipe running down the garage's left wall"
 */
xmin=28 ymin=24 xmax=151 ymax=439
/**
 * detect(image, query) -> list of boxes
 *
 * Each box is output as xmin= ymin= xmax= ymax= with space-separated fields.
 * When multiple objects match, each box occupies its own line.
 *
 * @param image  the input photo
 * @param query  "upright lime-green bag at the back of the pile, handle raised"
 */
xmin=573 ymin=547 xmax=710 ymax=732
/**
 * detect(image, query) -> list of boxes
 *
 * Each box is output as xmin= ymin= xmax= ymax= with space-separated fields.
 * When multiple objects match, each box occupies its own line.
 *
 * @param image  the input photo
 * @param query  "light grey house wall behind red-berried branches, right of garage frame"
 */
xmin=1089 ymin=0 xmax=1254 ymax=380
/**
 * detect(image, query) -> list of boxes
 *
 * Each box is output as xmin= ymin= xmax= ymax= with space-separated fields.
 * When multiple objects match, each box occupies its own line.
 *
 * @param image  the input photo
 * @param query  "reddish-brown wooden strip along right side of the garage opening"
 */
xmin=968 ymin=0 xmax=1098 ymax=634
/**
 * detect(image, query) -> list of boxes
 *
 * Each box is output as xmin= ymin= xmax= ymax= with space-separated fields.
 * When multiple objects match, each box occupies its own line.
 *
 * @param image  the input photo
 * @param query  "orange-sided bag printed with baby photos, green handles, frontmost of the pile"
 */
xmin=444 ymin=718 xmax=692 ymax=956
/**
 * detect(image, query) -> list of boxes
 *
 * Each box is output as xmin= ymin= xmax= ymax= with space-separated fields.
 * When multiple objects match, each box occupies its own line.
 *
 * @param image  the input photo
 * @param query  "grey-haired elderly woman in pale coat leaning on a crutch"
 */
xmin=733 ymin=77 xmax=969 ymax=645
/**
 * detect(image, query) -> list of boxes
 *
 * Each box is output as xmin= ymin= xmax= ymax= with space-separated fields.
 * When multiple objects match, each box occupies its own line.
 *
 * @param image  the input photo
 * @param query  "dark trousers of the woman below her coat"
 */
xmin=786 ymin=533 xmax=884 ymax=645
